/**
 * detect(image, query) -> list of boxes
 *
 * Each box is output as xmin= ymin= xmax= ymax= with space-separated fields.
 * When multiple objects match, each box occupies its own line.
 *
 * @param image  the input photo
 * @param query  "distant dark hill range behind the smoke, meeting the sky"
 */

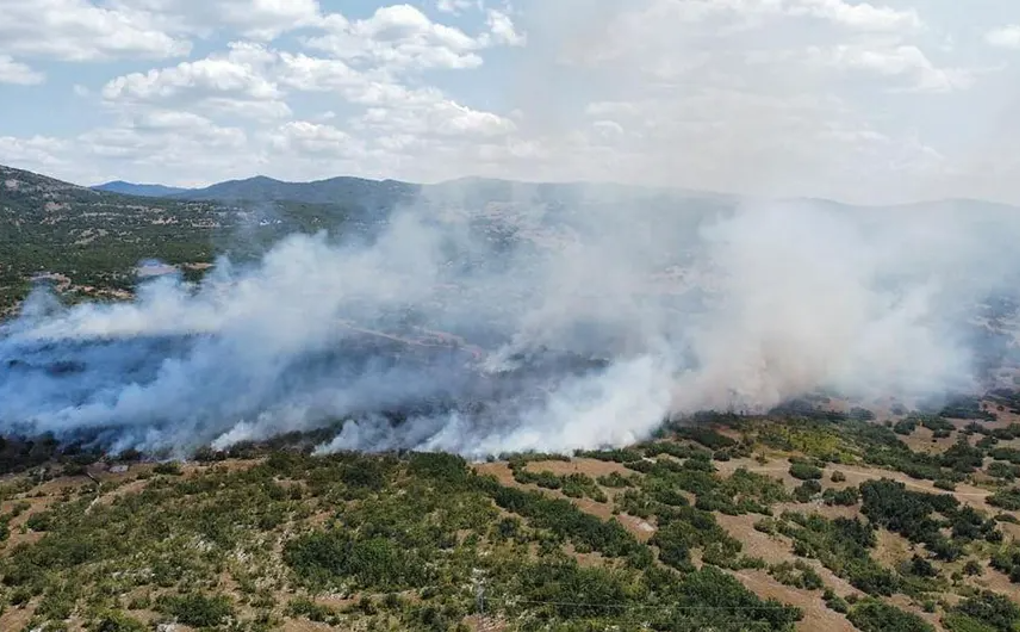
xmin=0 ymin=166 xmax=732 ymax=315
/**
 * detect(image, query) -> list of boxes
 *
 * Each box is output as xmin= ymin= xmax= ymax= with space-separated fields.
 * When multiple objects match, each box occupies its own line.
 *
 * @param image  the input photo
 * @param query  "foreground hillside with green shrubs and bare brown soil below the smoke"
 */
xmin=0 ymin=403 xmax=1020 ymax=632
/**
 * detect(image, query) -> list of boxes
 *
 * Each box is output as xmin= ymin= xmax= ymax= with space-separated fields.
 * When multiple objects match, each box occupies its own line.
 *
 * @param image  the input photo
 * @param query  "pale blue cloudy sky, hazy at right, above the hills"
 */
xmin=0 ymin=0 xmax=1020 ymax=203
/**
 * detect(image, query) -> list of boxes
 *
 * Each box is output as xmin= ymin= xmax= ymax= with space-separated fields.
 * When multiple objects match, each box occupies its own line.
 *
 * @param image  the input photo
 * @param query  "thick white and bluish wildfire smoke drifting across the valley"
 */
xmin=0 ymin=192 xmax=1020 ymax=456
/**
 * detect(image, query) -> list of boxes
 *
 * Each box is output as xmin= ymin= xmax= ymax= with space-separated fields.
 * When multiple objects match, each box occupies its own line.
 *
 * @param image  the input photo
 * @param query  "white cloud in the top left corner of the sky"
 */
xmin=0 ymin=0 xmax=191 ymax=61
